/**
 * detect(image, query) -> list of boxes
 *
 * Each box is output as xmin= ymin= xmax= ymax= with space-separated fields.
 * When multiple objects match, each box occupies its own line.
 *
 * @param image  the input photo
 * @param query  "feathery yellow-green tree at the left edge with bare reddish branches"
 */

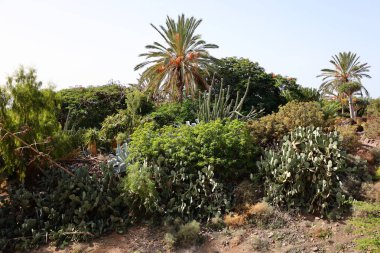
xmin=0 ymin=67 xmax=78 ymax=179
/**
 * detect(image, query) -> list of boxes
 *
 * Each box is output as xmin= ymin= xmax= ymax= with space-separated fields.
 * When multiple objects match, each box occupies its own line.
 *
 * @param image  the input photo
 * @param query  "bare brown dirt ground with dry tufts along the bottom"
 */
xmin=33 ymin=213 xmax=366 ymax=253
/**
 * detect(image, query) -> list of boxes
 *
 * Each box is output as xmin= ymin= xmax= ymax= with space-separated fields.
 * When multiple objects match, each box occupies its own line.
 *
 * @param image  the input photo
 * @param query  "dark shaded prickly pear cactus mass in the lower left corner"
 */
xmin=0 ymin=168 xmax=130 ymax=251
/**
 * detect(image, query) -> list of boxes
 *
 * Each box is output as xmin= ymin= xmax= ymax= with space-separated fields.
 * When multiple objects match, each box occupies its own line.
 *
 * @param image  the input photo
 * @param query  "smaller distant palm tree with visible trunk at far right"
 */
xmin=318 ymin=52 xmax=371 ymax=118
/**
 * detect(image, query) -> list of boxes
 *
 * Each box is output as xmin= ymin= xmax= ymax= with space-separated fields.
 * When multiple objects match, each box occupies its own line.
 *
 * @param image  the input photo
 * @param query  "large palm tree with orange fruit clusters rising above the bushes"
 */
xmin=135 ymin=14 xmax=218 ymax=101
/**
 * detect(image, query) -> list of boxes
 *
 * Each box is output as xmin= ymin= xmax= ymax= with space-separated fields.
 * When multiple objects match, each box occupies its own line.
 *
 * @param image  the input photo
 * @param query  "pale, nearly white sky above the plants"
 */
xmin=0 ymin=0 xmax=380 ymax=97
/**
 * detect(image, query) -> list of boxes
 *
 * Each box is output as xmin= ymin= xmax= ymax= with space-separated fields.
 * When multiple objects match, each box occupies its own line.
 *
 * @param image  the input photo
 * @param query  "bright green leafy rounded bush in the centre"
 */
xmin=130 ymin=120 xmax=259 ymax=182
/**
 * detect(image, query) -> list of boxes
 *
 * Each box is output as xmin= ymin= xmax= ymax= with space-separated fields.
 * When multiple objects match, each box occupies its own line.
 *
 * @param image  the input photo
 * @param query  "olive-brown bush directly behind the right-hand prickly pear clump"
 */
xmin=249 ymin=101 xmax=326 ymax=146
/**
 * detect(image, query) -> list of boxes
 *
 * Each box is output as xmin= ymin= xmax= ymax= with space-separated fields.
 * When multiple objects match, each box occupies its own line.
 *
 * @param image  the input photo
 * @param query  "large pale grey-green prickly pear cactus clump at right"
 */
xmin=258 ymin=127 xmax=358 ymax=215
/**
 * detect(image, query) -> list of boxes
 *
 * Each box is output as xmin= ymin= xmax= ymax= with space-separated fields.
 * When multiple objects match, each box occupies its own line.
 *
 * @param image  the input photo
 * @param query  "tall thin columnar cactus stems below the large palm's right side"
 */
xmin=197 ymin=79 xmax=262 ymax=122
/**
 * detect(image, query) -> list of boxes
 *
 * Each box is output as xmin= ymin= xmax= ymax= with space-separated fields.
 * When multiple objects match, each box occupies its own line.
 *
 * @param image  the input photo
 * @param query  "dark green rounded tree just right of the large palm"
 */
xmin=214 ymin=57 xmax=286 ymax=114
